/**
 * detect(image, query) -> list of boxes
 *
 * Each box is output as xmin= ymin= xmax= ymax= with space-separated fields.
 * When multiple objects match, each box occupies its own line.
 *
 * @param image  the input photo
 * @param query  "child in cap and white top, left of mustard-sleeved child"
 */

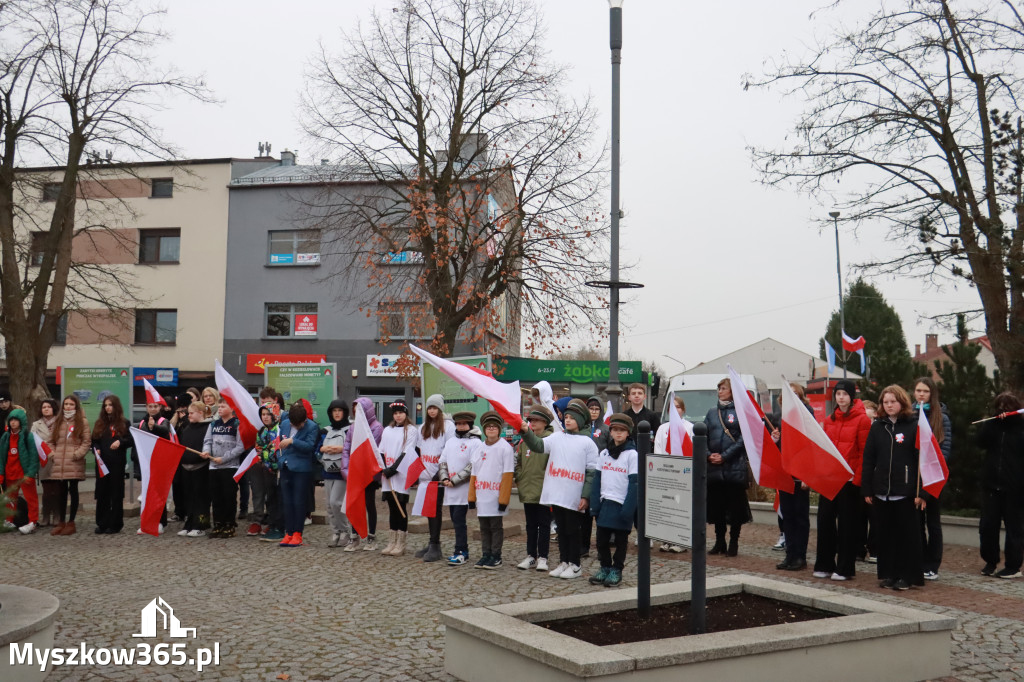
xmin=437 ymin=412 xmax=482 ymax=566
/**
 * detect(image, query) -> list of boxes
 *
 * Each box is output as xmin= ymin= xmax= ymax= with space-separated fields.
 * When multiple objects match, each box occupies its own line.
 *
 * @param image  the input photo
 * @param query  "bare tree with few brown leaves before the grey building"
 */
xmin=304 ymin=0 xmax=606 ymax=354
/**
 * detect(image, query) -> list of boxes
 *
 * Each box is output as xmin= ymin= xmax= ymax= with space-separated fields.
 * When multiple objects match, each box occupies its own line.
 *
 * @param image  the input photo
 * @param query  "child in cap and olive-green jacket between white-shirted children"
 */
xmin=515 ymin=404 xmax=554 ymax=571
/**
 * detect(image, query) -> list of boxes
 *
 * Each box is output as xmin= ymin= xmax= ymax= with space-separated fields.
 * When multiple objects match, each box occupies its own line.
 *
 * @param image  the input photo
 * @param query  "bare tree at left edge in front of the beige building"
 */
xmin=0 ymin=0 xmax=206 ymax=403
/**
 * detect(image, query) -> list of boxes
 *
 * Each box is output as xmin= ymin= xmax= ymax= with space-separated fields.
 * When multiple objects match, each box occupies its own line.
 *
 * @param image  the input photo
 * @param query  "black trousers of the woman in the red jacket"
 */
xmin=814 ymin=483 xmax=864 ymax=578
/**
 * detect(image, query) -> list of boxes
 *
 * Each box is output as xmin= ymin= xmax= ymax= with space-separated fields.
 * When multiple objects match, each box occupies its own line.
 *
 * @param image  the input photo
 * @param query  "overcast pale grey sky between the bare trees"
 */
xmin=148 ymin=0 xmax=980 ymax=374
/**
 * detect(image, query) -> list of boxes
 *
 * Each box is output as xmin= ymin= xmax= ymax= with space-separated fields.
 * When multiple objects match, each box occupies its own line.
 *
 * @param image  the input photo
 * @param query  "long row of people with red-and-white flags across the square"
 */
xmin=0 ymin=378 xmax=1024 ymax=590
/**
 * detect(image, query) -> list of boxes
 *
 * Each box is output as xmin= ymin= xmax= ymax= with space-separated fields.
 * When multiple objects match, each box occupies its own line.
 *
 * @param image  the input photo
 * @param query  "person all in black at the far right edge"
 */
xmin=978 ymin=392 xmax=1024 ymax=578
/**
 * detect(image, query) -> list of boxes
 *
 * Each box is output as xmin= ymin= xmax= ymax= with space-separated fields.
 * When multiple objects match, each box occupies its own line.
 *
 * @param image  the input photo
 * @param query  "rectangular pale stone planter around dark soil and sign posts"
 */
xmin=441 ymin=576 xmax=956 ymax=682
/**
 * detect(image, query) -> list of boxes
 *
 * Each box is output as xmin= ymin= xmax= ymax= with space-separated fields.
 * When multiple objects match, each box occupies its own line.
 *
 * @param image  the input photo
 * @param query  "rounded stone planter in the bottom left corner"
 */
xmin=0 ymin=585 xmax=60 ymax=682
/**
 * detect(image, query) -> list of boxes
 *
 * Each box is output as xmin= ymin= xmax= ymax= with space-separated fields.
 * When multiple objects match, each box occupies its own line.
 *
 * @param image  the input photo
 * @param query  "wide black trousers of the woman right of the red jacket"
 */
xmin=871 ymin=497 xmax=925 ymax=585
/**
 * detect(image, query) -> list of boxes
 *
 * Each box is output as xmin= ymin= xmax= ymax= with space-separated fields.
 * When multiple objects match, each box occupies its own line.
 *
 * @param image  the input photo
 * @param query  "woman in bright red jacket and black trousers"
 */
xmin=814 ymin=379 xmax=871 ymax=581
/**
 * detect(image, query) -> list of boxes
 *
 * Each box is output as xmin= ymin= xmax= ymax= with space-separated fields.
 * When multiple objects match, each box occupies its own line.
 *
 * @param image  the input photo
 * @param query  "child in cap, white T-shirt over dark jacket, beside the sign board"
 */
xmin=590 ymin=413 xmax=639 ymax=587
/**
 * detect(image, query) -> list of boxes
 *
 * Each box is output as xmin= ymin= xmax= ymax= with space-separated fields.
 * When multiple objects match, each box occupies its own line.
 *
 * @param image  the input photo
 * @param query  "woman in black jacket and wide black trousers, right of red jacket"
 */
xmin=860 ymin=386 xmax=925 ymax=590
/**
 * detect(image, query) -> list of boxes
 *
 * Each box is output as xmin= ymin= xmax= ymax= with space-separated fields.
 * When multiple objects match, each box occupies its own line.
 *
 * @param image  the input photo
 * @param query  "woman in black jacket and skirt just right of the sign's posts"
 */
xmin=705 ymin=379 xmax=754 ymax=556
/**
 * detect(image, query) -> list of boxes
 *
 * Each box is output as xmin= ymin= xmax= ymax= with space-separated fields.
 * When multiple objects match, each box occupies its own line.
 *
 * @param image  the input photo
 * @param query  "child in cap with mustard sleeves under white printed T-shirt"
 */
xmin=468 ymin=410 xmax=515 ymax=570
